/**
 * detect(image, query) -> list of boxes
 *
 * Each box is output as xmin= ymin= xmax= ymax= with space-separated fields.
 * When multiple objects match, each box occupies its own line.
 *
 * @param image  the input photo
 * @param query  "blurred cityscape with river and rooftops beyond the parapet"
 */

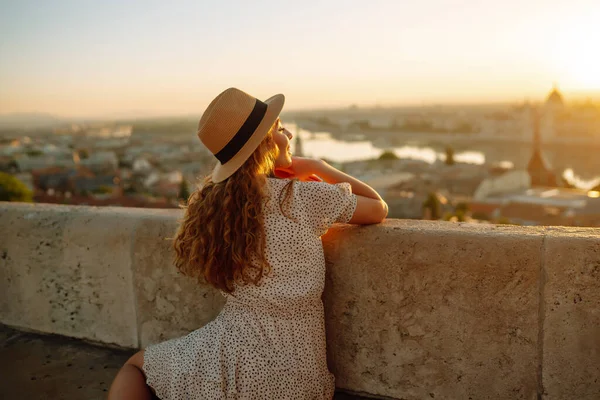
xmin=0 ymin=86 xmax=600 ymax=226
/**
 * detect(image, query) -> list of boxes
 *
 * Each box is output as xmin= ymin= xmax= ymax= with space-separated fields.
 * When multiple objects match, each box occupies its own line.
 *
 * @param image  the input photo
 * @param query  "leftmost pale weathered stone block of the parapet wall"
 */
xmin=0 ymin=204 xmax=138 ymax=347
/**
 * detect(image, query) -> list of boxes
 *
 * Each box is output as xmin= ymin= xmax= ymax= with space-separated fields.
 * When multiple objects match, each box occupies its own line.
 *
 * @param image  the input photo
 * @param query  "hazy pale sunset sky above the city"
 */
xmin=0 ymin=0 xmax=600 ymax=116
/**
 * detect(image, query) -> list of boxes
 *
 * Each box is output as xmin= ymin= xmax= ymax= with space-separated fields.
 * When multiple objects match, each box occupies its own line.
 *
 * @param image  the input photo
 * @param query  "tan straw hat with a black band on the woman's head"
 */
xmin=198 ymin=88 xmax=285 ymax=183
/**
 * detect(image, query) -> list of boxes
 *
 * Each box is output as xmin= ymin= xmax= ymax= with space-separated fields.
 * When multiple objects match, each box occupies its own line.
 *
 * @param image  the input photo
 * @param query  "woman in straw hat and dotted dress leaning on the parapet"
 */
xmin=109 ymin=88 xmax=387 ymax=400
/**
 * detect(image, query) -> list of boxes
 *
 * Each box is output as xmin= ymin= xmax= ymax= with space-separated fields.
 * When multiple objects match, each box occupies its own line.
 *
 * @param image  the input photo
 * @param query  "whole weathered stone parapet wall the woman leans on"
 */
xmin=0 ymin=202 xmax=600 ymax=399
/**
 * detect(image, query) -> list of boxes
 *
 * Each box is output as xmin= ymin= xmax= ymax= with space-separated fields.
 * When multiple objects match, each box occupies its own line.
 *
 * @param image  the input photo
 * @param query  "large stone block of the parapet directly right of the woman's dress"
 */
xmin=325 ymin=221 xmax=543 ymax=399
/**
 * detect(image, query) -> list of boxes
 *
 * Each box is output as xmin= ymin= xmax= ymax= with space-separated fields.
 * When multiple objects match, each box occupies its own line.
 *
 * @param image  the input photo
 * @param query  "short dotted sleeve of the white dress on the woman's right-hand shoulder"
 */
xmin=301 ymin=182 xmax=357 ymax=236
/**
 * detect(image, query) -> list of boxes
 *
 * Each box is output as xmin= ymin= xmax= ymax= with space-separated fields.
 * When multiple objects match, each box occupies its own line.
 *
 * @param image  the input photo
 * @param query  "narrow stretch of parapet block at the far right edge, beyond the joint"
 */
xmin=542 ymin=228 xmax=600 ymax=400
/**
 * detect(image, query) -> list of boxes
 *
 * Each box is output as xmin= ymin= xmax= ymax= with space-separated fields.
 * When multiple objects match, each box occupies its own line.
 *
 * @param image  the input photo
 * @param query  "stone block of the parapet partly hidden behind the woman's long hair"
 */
xmin=132 ymin=211 xmax=225 ymax=347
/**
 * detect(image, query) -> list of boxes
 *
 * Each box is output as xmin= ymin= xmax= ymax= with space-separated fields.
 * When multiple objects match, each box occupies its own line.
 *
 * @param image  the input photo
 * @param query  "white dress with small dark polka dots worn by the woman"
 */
xmin=143 ymin=178 xmax=356 ymax=400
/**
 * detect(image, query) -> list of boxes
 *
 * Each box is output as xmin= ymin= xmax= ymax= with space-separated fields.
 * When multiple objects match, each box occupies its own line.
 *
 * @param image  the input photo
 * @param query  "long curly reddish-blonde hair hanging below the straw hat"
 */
xmin=173 ymin=128 xmax=293 ymax=293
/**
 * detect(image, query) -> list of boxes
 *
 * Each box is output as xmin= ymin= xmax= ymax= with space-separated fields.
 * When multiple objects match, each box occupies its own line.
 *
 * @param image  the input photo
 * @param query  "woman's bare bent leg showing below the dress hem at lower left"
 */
xmin=108 ymin=350 xmax=156 ymax=400
